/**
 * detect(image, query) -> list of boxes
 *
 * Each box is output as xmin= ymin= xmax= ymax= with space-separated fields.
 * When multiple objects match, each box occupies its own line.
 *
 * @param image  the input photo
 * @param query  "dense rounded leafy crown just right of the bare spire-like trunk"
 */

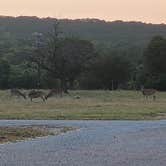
xmin=59 ymin=38 xmax=95 ymax=89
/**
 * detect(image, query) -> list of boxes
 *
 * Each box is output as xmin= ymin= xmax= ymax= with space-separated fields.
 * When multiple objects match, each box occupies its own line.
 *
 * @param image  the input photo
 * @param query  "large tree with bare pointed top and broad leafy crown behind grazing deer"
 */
xmin=31 ymin=23 xmax=94 ymax=93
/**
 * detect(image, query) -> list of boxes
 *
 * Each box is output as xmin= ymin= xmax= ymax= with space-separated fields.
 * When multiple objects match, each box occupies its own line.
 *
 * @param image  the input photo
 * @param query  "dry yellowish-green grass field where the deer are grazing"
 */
xmin=0 ymin=91 xmax=166 ymax=120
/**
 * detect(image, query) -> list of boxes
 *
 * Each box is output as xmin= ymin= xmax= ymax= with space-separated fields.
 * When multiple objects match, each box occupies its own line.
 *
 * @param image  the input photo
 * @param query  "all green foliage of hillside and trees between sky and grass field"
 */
xmin=0 ymin=17 xmax=166 ymax=90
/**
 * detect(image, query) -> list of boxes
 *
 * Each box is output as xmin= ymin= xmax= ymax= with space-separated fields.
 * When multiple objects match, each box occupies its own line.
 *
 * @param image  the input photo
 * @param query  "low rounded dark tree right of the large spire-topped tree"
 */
xmin=82 ymin=54 xmax=131 ymax=90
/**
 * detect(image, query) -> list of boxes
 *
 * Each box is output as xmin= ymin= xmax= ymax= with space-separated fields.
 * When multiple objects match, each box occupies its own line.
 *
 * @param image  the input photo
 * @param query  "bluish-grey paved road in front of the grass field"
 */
xmin=0 ymin=121 xmax=166 ymax=166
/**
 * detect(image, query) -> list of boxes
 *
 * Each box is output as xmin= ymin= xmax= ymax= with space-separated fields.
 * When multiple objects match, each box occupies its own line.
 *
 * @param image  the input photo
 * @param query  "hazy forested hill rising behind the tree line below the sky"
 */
xmin=0 ymin=16 xmax=166 ymax=48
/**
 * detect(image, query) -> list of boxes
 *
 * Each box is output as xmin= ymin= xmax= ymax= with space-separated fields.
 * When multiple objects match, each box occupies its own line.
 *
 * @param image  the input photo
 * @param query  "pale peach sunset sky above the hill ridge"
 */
xmin=0 ymin=0 xmax=166 ymax=23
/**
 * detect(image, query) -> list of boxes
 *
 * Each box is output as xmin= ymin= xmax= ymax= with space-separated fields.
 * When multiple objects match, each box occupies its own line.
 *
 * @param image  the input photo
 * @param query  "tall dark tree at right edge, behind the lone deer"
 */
xmin=144 ymin=36 xmax=166 ymax=90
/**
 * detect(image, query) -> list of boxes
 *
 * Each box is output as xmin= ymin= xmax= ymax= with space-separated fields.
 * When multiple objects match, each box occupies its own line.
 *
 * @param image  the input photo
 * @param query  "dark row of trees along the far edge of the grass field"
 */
xmin=0 ymin=23 xmax=166 ymax=93
